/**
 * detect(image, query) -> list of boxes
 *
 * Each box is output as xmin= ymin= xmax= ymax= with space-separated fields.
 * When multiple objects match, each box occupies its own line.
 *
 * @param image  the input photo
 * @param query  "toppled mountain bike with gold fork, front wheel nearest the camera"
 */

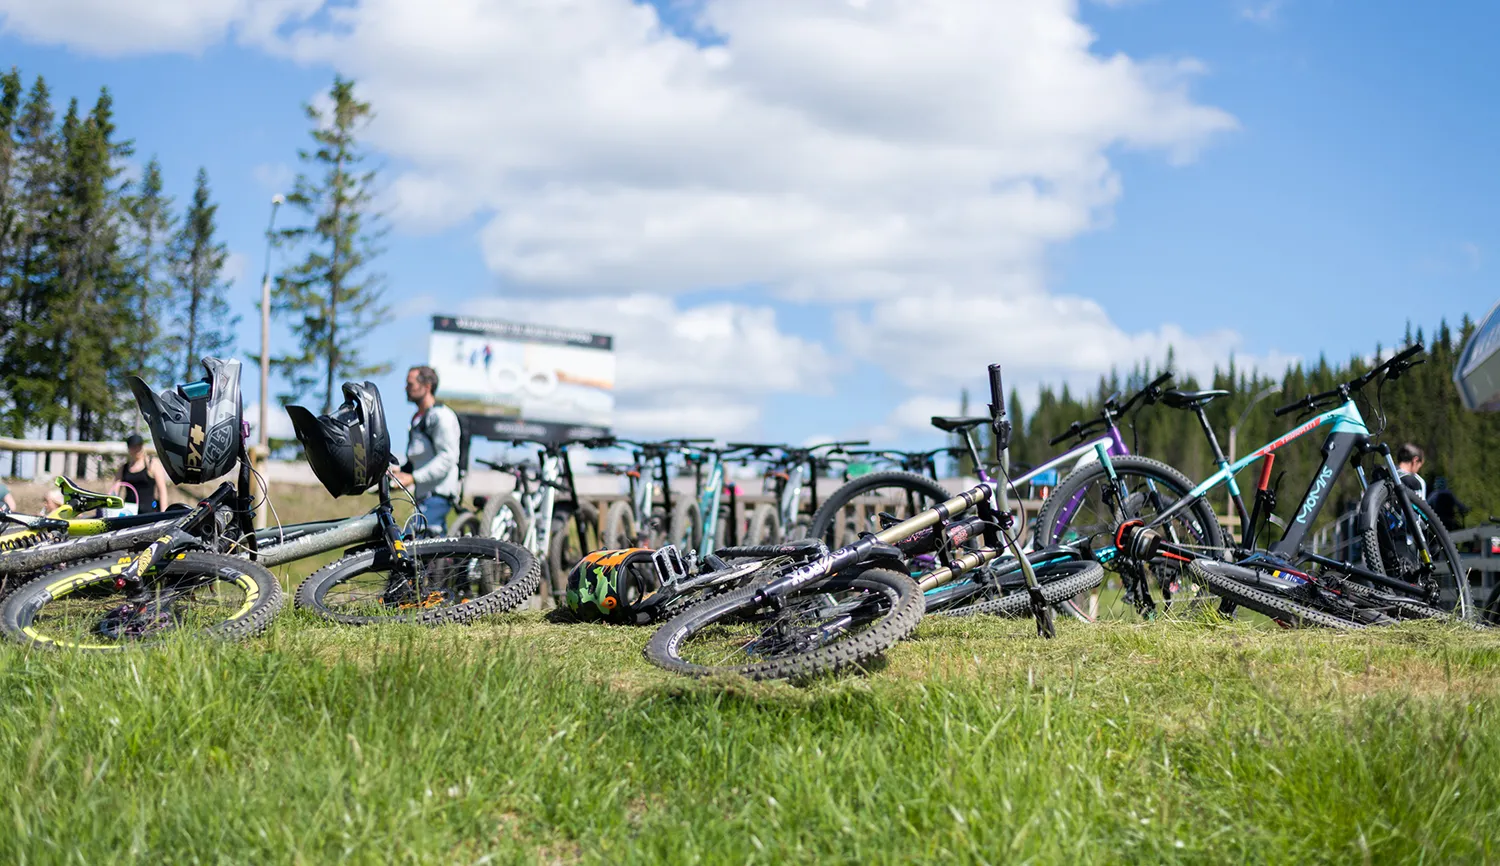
xmin=645 ymin=365 xmax=1104 ymax=680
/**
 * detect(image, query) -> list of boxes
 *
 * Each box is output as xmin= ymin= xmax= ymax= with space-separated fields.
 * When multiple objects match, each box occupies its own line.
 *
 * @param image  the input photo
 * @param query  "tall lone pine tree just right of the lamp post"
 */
xmin=272 ymin=78 xmax=390 ymax=411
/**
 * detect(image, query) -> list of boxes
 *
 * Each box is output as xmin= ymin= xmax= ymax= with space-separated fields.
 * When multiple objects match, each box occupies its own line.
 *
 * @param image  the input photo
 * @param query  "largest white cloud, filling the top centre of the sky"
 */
xmin=243 ymin=0 xmax=1233 ymax=299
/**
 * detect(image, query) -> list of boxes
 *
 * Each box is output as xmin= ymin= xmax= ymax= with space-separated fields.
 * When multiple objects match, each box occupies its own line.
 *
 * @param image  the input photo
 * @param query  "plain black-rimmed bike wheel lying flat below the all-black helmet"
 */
xmin=297 ymin=537 xmax=542 ymax=626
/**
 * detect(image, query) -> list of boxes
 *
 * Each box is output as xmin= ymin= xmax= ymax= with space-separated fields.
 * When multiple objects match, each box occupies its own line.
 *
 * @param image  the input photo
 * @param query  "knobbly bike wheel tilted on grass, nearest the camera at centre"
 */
xmin=645 ymin=569 xmax=923 ymax=680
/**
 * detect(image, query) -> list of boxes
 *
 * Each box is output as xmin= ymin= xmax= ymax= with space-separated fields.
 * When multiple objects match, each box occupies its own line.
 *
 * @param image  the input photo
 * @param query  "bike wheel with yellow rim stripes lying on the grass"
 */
xmin=0 ymin=552 xmax=285 ymax=651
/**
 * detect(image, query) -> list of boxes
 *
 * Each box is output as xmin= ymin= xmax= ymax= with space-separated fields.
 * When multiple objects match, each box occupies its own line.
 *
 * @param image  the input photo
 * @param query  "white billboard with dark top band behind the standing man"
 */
xmin=428 ymin=315 xmax=615 ymax=440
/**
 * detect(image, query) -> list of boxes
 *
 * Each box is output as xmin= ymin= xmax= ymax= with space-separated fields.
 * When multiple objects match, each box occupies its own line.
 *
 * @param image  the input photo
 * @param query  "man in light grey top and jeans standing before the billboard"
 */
xmin=392 ymin=366 xmax=461 ymax=536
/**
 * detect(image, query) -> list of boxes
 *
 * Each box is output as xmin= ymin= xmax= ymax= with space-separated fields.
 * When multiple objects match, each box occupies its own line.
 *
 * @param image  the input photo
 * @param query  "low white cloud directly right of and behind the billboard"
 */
xmin=467 ymin=294 xmax=833 ymax=437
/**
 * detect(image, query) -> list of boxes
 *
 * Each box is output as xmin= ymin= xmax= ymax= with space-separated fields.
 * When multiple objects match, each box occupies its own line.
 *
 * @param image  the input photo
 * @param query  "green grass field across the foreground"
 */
xmin=0 ymin=614 xmax=1500 ymax=863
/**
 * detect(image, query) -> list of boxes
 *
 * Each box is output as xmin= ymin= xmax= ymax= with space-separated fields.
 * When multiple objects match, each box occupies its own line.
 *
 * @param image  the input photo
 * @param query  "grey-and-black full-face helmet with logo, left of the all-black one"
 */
xmin=131 ymin=357 xmax=245 ymax=485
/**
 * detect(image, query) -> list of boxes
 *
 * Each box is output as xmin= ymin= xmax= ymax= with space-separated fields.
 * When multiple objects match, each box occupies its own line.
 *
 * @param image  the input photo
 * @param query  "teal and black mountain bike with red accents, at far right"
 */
xmin=1110 ymin=344 xmax=1475 ymax=627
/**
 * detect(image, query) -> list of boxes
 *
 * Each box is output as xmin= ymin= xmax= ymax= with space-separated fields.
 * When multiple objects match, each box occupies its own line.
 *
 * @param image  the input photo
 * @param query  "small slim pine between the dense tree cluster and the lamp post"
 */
xmin=168 ymin=168 xmax=240 ymax=380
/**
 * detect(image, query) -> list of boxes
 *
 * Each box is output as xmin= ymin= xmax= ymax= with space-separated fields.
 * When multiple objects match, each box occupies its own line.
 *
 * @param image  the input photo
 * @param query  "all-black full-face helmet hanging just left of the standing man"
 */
xmin=287 ymin=381 xmax=390 ymax=497
